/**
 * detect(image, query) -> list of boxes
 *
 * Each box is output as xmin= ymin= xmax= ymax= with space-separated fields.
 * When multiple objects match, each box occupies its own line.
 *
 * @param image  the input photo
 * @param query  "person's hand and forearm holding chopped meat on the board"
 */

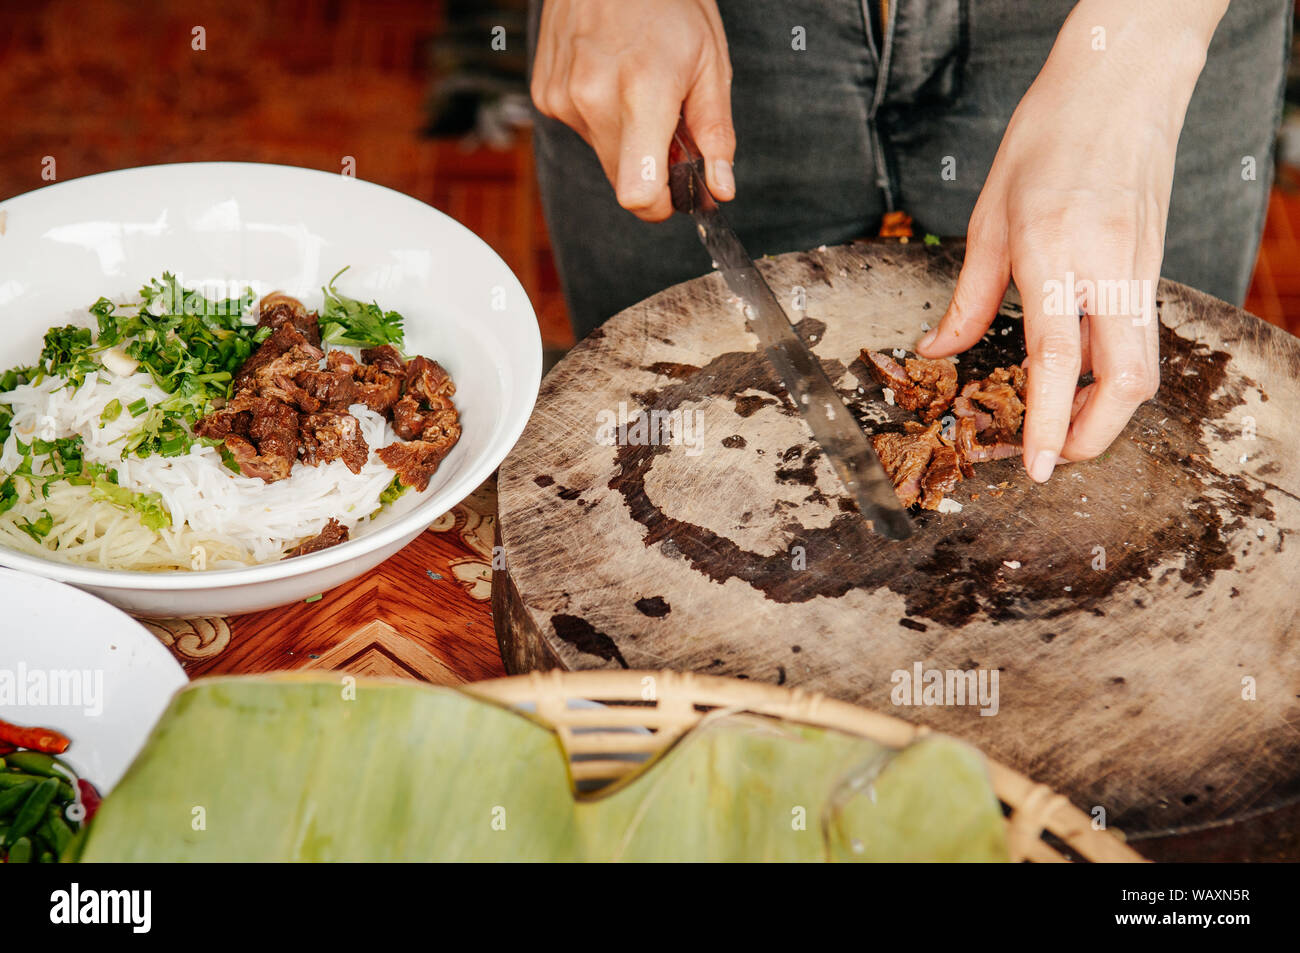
xmin=917 ymin=0 xmax=1227 ymax=482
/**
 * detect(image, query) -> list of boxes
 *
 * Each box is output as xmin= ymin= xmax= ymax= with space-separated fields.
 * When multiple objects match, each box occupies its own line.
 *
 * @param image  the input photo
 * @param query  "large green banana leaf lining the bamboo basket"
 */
xmin=79 ymin=675 xmax=1008 ymax=861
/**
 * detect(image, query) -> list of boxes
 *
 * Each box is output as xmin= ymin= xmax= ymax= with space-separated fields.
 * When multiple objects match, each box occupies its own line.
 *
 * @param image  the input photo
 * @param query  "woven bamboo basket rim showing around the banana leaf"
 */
xmin=464 ymin=670 xmax=1144 ymax=863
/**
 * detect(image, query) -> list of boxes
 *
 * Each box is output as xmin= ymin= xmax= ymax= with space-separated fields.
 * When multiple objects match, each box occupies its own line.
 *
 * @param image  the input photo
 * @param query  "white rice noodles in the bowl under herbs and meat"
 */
xmin=0 ymin=356 xmax=397 ymax=571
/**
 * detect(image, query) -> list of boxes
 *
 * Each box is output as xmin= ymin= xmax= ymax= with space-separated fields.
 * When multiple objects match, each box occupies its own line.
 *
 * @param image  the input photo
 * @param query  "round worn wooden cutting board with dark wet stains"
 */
xmin=494 ymin=242 xmax=1300 ymax=832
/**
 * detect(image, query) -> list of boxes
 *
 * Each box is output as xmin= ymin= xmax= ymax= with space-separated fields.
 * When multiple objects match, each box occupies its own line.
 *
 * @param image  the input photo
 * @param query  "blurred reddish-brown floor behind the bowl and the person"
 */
xmin=0 ymin=0 xmax=1300 ymax=350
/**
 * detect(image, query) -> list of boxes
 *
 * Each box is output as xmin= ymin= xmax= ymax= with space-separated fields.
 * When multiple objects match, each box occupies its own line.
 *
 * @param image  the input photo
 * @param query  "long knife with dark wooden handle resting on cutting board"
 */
xmin=668 ymin=118 xmax=911 ymax=540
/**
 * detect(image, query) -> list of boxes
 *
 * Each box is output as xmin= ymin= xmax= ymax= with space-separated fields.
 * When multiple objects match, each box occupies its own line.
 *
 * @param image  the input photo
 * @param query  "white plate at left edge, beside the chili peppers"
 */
xmin=0 ymin=569 xmax=186 ymax=794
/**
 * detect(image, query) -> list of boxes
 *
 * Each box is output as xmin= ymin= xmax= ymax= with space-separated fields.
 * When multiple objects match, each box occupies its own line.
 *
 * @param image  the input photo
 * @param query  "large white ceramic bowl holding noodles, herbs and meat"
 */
xmin=0 ymin=163 xmax=542 ymax=618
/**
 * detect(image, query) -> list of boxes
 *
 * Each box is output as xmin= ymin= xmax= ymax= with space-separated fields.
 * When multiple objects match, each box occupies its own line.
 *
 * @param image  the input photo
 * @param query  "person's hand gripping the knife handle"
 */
xmin=532 ymin=0 xmax=736 ymax=221
